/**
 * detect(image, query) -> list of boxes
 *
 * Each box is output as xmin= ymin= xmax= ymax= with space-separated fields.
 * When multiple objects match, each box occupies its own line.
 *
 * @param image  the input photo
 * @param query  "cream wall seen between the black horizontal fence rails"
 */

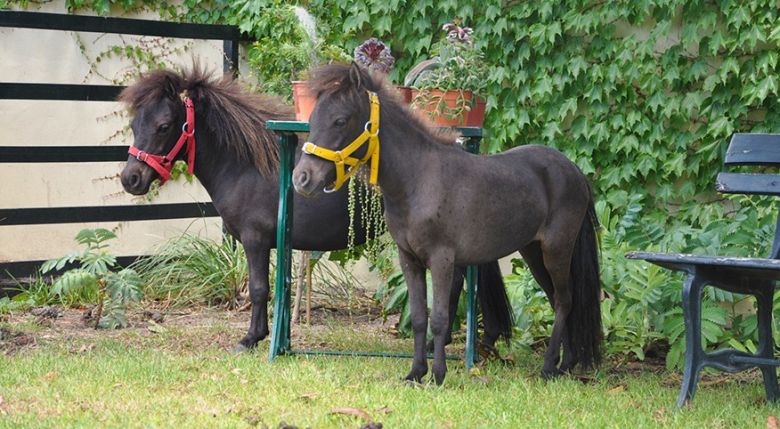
xmin=0 ymin=1 xmax=222 ymax=262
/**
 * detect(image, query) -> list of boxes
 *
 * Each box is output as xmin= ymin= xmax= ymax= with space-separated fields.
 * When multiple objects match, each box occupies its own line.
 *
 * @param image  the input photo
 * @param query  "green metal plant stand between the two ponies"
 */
xmin=266 ymin=121 xmax=482 ymax=368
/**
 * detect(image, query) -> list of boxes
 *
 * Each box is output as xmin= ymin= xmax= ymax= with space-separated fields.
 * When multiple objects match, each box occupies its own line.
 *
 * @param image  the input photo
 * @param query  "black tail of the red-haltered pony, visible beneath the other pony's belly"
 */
xmin=477 ymin=261 xmax=515 ymax=346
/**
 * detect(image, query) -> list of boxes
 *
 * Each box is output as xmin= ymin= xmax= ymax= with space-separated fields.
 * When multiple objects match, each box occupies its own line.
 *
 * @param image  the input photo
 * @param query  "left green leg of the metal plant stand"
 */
xmin=268 ymin=133 xmax=298 ymax=362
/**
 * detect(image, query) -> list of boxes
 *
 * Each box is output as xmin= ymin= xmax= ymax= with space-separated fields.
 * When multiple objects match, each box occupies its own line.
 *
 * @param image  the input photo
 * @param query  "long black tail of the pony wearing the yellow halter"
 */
xmin=566 ymin=198 xmax=603 ymax=368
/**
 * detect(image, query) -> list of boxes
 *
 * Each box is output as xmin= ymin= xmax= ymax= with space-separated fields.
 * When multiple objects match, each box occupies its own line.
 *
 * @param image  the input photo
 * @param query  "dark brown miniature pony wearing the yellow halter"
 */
xmin=293 ymin=64 xmax=602 ymax=384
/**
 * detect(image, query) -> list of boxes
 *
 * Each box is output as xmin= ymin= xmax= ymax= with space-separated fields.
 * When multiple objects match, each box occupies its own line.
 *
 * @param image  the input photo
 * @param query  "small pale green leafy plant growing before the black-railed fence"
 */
xmin=41 ymin=228 xmax=142 ymax=329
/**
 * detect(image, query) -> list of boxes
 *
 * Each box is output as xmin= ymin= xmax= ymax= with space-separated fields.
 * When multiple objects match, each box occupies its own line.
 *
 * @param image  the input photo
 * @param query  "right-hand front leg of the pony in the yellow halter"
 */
xmin=430 ymin=251 xmax=454 ymax=385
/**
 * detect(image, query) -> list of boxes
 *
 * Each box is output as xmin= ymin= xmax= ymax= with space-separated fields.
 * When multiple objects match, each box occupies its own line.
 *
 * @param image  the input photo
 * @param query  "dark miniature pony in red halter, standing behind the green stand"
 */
xmin=119 ymin=67 xmax=512 ymax=351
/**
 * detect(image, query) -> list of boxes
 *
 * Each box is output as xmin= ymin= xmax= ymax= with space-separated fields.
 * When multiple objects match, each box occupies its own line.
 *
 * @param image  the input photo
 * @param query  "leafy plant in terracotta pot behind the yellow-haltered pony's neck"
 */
xmin=412 ymin=20 xmax=486 ymax=127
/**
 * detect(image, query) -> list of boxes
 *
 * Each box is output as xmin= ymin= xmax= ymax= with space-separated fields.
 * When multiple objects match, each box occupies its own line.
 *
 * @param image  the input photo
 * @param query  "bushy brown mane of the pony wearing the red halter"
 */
xmin=118 ymin=63 xmax=293 ymax=175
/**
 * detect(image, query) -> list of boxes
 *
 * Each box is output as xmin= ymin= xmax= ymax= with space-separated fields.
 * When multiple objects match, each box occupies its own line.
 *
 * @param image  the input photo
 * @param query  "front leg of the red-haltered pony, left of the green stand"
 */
xmin=235 ymin=243 xmax=270 ymax=352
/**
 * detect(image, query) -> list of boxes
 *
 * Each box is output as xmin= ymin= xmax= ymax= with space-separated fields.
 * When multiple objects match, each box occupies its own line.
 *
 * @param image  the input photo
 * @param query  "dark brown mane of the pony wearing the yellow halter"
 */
xmin=309 ymin=63 xmax=457 ymax=145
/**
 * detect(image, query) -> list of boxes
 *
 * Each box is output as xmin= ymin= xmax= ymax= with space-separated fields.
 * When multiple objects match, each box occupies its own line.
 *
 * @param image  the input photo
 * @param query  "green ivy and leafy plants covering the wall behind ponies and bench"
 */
xmin=9 ymin=0 xmax=780 ymax=365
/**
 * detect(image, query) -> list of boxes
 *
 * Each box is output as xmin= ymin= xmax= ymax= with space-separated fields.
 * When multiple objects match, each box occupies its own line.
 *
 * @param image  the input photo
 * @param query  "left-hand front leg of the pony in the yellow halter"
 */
xmin=398 ymin=248 xmax=428 ymax=383
